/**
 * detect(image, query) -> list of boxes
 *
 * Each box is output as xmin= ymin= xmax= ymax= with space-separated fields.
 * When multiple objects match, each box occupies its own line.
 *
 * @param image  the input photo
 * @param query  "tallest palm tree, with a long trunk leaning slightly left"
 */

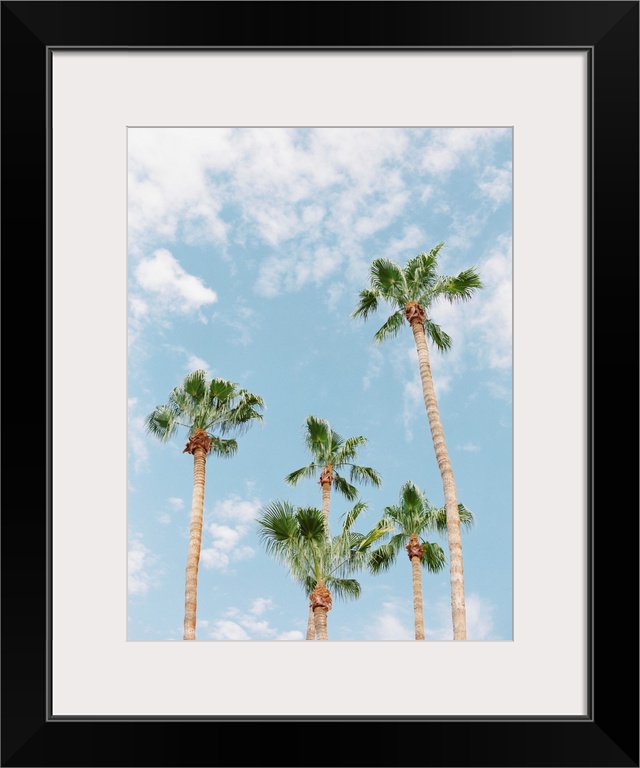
xmin=352 ymin=243 xmax=482 ymax=640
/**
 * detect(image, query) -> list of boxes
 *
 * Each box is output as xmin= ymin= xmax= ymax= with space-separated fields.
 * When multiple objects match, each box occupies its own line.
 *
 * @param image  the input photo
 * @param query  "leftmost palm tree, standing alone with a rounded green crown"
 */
xmin=145 ymin=370 xmax=264 ymax=640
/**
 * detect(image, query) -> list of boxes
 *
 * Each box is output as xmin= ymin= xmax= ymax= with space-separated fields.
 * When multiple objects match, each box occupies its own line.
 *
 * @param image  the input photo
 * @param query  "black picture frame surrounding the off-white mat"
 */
xmin=1 ymin=0 xmax=639 ymax=768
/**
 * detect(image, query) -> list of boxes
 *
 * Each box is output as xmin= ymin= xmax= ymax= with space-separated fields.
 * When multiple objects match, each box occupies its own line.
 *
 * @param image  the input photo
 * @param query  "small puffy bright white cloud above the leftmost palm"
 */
xmin=134 ymin=248 xmax=217 ymax=314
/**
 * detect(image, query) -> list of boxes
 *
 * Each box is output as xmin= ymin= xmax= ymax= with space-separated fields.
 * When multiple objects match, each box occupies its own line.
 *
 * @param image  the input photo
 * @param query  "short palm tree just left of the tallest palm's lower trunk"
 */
xmin=369 ymin=482 xmax=473 ymax=640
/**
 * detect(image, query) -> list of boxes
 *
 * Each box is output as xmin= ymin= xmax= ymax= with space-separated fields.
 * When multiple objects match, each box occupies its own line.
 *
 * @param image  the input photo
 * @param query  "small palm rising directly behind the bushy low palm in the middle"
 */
xmin=285 ymin=416 xmax=382 ymax=640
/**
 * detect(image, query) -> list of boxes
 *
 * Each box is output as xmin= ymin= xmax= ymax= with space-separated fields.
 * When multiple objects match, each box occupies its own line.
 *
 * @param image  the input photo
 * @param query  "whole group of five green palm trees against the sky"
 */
xmin=145 ymin=243 xmax=482 ymax=640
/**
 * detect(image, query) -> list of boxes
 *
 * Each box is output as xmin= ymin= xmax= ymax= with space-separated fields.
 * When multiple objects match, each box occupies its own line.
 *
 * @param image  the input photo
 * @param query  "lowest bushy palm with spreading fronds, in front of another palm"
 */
xmin=257 ymin=501 xmax=389 ymax=640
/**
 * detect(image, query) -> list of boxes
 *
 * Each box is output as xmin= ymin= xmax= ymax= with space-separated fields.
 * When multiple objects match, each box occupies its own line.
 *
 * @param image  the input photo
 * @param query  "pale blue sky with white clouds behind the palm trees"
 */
xmin=127 ymin=127 xmax=513 ymax=641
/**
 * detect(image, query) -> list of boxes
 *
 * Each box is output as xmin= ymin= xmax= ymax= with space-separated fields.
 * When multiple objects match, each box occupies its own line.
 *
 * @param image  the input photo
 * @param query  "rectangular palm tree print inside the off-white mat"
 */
xmin=127 ymin=126 xmax=513 ymax=642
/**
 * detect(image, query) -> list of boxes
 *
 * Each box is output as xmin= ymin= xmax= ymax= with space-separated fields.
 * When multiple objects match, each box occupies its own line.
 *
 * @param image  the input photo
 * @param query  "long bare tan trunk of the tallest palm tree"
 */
xmin=411 ymin=319 xmax=467 ymax=640
